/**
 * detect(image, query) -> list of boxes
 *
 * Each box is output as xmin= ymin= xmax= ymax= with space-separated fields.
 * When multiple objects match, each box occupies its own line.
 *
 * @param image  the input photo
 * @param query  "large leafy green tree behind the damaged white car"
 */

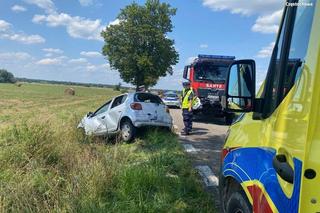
xmin=101 ymin=0 xmax=179 ymax=89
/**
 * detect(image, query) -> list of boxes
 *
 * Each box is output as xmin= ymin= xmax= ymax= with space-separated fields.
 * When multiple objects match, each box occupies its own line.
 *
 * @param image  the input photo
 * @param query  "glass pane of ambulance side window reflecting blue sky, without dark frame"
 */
xmin=282 ymin=0 xmax=316 ymax=98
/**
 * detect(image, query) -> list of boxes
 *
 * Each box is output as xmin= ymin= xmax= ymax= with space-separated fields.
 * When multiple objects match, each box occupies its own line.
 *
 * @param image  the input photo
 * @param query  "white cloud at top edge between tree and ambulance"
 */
xmin=202 ymin=0 xmax=284 ymax=33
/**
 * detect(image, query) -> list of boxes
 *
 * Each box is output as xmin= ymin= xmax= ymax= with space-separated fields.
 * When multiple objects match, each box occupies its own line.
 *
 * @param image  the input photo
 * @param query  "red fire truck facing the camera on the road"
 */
xmin=183 ymin=55 xmax=235 ymax=123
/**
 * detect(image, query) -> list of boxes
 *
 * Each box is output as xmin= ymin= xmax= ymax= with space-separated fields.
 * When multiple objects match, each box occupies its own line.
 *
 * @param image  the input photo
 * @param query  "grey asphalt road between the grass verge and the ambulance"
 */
xmin=170 ymin=109 xmax=228 ymax=210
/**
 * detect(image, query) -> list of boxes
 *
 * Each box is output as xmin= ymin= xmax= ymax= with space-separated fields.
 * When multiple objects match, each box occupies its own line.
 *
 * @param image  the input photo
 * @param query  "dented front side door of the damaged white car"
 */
xmin=87 ymin=101 xmax=111 ymax=135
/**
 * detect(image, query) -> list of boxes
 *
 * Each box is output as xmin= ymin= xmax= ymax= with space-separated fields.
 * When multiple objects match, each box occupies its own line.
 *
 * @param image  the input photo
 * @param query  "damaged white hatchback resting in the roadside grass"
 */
xmin=78 ymin=92 xmax=172 ymax=141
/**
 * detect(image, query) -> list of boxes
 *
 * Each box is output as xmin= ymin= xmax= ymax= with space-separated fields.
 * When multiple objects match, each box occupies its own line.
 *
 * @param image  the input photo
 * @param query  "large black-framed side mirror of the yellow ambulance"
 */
xmin=222 ymin=60 xmax=256 ymax=112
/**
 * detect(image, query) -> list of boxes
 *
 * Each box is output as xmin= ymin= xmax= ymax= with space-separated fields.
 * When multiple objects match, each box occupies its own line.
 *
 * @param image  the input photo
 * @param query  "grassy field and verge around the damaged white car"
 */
xmin=0 ymin=83 xmax=214 ymax=212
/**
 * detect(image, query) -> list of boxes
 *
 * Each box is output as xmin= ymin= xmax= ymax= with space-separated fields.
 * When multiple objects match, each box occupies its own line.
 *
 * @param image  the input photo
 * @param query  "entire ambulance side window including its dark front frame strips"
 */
xmin=263 ymin=0 xmax=316 ymax=117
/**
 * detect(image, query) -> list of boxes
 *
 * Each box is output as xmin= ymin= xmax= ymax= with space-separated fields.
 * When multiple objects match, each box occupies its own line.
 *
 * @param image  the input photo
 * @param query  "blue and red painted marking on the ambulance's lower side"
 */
xmin=222 ymin=147 xmax=302 ymax=213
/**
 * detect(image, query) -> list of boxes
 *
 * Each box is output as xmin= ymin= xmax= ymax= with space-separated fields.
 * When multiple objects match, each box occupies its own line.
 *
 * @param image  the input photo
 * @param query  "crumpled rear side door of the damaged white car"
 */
xmin=106 ymin=94 xmax=128 ymax=132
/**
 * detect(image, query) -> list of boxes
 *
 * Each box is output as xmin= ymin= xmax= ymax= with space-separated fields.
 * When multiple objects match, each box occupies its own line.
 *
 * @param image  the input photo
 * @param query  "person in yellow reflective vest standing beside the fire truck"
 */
xmin=181 ymin=82 xmax=194 ymax=135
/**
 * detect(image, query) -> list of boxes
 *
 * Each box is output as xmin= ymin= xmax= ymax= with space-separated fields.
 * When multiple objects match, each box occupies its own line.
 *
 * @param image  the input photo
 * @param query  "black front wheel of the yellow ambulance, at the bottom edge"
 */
xmin=226 ymin=191 xmax=252 ymax=213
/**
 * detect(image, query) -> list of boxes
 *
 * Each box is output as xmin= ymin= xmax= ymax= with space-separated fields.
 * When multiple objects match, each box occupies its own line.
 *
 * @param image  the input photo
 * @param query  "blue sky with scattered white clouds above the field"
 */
xmin=0 ymin=0 xmax=284 ymax=89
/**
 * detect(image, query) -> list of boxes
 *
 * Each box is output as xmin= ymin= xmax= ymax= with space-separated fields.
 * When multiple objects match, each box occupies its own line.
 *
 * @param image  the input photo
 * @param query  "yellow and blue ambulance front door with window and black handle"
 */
xmin=252 ymin=0 xmax=317 ymax=212
